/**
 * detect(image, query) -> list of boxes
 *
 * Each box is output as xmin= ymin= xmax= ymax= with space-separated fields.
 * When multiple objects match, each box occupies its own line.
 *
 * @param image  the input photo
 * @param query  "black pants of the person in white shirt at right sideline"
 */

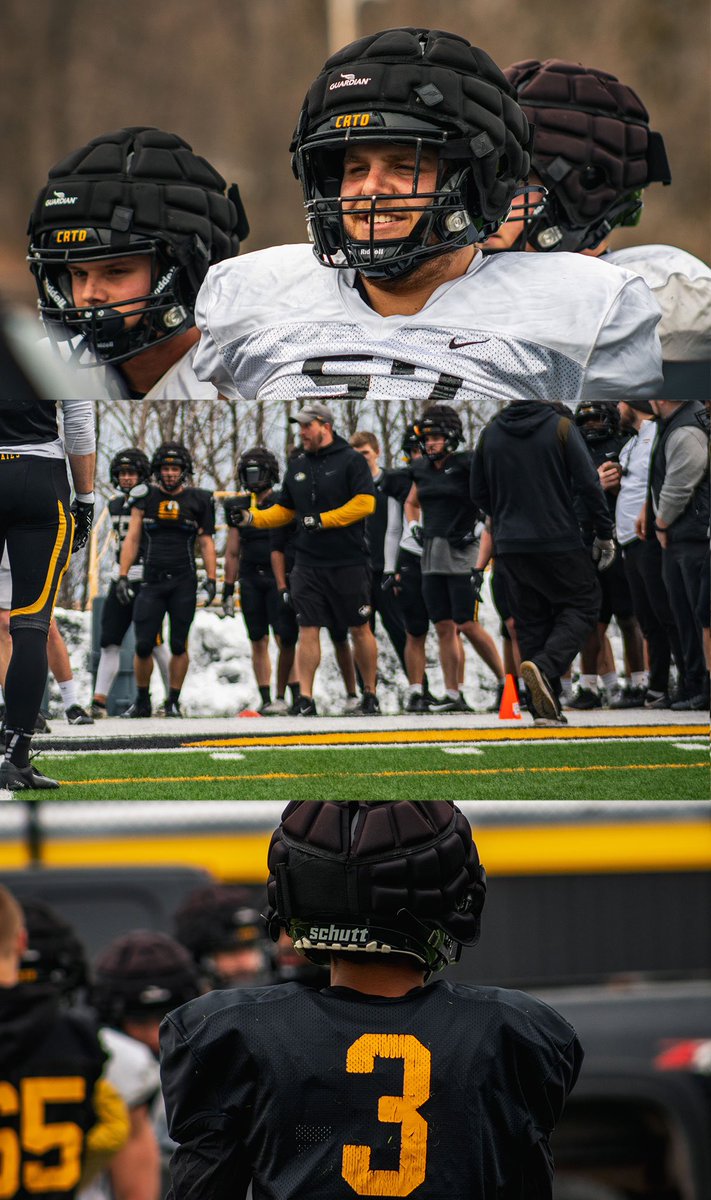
xmin=622 ymin=538 xmax=683 ymax=692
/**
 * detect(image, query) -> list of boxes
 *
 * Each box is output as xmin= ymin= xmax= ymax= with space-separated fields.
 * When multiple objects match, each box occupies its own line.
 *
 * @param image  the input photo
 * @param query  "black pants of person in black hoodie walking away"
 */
xmin=496 ymin=548 xmax=601 ymax=695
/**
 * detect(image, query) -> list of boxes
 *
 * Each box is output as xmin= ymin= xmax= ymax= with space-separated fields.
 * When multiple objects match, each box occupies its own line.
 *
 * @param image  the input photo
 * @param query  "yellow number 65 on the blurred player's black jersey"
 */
xmin=0 ymin=1075 xmax=86 ymax=1200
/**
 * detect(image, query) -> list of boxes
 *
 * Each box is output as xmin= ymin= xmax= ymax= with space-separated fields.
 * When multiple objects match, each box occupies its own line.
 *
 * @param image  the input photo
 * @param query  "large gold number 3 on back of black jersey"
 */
xmin=341 ymin=1033 xmax=431 ymax=1196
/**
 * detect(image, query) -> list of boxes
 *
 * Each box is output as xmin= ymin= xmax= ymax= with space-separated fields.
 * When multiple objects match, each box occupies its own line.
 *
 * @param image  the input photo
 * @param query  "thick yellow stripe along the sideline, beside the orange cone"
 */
xmin=181 ymin=725 xmax=709 ymax=749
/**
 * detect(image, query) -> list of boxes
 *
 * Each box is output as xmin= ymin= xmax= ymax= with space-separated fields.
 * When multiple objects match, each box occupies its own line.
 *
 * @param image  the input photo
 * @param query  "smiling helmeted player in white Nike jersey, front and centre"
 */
xmin=195 ymin=29 xmax=661 ymax=407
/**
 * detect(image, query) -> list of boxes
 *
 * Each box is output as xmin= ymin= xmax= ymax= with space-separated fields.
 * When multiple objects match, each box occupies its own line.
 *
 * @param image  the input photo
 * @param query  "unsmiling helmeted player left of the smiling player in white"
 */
xmin=29 ymin=126 xmax=249 ymax=401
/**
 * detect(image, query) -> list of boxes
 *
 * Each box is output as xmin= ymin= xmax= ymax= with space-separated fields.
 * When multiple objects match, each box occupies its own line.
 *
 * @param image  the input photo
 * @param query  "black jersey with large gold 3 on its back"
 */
xmin=161 ymin=980 xmax=582 ymax=1200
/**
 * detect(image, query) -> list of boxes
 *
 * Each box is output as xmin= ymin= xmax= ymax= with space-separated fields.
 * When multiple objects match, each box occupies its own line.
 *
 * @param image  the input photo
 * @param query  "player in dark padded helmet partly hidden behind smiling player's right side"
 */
xmin=486 ymin=59 xmax=711 ymax=400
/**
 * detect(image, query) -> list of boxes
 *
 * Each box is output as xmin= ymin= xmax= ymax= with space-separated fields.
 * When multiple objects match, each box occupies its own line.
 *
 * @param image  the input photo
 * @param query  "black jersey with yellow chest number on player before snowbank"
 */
xmin=131 ymin=487 xmax=215 ymax=582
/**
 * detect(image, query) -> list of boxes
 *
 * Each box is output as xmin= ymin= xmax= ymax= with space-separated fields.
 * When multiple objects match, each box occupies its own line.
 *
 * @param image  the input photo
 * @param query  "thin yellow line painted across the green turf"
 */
xmin=54 ymin=761 xmax=709 ymax=787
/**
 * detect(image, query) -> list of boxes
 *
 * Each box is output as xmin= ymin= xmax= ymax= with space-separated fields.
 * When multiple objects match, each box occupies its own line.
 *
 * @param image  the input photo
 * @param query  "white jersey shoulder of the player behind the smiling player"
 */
xmin=602 ymin=246 xmax=711 ymax=362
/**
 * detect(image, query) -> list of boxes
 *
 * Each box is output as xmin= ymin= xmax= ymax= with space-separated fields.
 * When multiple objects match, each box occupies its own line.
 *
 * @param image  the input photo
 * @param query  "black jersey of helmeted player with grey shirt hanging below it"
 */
xmin=410 ymin=450 xmax=479 ymax=540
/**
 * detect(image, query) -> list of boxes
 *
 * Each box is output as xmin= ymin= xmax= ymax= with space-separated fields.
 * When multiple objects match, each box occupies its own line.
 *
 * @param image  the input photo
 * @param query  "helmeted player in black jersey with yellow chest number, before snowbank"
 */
xmin=116 ymin=442 xmax=217 ymax=718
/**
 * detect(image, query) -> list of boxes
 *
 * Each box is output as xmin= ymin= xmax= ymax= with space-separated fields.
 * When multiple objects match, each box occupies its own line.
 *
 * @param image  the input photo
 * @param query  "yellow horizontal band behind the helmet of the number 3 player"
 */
xmin=11 ymin=817 xmax=711 ymax=883
